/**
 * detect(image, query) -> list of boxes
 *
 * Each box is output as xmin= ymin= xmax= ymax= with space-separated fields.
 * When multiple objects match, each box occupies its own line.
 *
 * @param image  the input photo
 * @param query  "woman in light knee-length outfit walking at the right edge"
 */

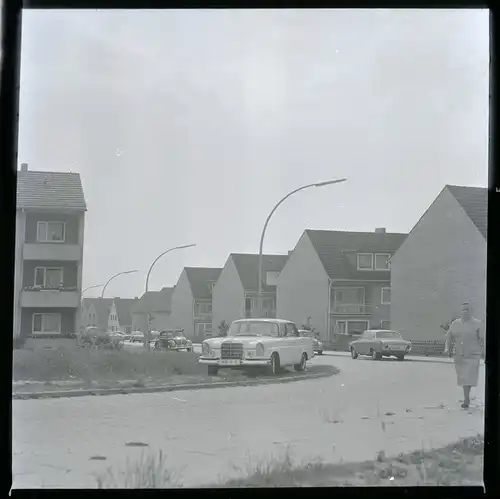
xmin=445 ymin=302 xmax=484 ymax=409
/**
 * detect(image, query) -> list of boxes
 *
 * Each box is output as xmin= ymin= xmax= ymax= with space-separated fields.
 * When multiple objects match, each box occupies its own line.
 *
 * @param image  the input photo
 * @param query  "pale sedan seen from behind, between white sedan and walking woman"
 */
xmin=349 ymin=329 xmax=411 ymax=360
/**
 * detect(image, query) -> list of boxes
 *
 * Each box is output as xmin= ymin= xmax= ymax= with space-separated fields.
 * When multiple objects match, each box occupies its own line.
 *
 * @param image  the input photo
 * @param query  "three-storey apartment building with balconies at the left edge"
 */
xmin=14 ymin=163 xmax=86 ymax=337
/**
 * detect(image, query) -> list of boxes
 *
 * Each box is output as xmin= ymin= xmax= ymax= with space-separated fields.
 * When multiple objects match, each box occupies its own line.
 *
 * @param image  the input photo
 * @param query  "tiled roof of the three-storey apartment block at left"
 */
xmin=17 ymin=170 xmax=86 ymax=211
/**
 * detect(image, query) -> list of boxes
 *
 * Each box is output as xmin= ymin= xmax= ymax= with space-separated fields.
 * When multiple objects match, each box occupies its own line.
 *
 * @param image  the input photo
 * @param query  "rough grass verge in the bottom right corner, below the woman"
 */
xmin=216 ymin=436 xmax=484 ymax=487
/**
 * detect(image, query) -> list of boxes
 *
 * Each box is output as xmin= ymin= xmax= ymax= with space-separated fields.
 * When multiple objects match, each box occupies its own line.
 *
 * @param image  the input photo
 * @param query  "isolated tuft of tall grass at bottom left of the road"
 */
xmin=95 ymin=451 xmax=180 ymax=489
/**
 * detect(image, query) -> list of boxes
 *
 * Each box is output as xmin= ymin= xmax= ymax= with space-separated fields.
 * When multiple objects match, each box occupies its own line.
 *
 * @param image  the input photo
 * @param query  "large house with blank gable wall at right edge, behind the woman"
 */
xmin=391 ymin=185 xmax=488 ymax=341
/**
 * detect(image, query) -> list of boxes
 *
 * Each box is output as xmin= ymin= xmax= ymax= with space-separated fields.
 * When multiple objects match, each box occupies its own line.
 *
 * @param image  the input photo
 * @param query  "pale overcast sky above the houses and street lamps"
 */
xmin=18 ymin=9 xmax=489 ymax=297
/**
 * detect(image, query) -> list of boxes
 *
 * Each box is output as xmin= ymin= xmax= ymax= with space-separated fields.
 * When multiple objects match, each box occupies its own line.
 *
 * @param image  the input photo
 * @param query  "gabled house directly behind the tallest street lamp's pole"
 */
xmin=212 ymin=253 xmax=288 ymax=334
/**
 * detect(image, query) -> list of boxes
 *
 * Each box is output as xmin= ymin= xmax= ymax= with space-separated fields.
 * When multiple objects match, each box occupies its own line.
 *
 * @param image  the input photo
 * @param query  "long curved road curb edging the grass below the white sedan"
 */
xmin=12 ymin=368 xmax=339 ymax=400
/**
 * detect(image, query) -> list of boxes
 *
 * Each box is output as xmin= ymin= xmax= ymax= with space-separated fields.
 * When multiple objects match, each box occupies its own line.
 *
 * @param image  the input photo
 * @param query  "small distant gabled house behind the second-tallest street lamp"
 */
xmin=131 ymin=286 xmax=175 ymax=333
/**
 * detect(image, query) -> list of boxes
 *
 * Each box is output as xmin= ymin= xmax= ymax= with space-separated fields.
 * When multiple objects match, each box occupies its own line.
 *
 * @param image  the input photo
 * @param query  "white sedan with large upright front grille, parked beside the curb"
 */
xmin=198 ymin=319 xmax=314 ymax=376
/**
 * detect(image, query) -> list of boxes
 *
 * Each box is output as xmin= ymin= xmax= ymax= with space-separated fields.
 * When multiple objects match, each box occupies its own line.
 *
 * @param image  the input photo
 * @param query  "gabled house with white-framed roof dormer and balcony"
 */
xmin=277 ymin=228 xmax=406 ymax=342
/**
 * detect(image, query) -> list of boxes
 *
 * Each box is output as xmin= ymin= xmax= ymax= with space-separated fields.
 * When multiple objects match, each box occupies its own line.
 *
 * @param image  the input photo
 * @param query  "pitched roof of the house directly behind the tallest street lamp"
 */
xmin=229 ymin=253 xmax=288 ymax=291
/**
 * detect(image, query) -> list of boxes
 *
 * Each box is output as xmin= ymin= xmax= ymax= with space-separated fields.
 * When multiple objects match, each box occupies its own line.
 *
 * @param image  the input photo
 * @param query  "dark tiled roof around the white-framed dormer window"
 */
xmin=305 ymin=229 xmax=407 ymax=281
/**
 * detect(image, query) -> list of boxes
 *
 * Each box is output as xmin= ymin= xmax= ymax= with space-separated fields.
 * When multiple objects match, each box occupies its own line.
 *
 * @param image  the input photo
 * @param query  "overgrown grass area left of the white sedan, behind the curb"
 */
xmin=13 ymin=345 xmax=206 ymax=386
